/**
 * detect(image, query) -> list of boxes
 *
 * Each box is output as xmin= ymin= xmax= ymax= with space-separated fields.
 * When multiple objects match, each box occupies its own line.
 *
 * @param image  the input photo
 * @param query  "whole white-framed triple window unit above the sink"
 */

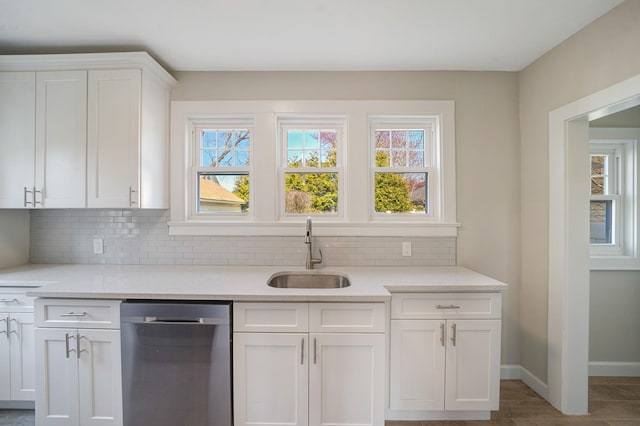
xmin=169 ymin=101 xmax=458 ymax=237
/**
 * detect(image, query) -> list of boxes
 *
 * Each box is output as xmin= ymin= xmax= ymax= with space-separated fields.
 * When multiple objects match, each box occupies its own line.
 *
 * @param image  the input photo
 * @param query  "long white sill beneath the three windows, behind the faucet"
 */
xmin=168 ymin=221 xmax=460 ymax=237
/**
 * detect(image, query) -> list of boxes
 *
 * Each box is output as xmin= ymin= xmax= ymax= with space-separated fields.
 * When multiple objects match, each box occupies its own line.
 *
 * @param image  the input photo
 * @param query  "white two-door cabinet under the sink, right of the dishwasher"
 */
xmin=233 ymin=303 xmax=385 ymax=426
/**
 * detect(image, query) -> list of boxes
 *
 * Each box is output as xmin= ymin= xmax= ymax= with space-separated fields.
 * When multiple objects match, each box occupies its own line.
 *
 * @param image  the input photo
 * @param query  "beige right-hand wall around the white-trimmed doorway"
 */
xmin=519 ymin=0 xmax=640 ymax=381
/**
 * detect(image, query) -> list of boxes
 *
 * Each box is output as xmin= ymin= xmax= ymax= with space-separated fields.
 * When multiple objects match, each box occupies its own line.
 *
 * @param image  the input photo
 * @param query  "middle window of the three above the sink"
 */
xmin=278 ymin=117 xmax=344 ymax=219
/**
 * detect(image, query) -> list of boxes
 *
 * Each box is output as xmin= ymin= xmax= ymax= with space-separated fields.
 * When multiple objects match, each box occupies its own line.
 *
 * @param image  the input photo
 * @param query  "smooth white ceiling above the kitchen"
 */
xmin=0 ymin=0 xmax=622 ymax=71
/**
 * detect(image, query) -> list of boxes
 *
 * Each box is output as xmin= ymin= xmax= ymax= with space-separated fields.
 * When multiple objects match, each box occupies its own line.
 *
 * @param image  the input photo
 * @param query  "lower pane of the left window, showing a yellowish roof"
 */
xmin=198 ymin=173 xmax=249 ymax=213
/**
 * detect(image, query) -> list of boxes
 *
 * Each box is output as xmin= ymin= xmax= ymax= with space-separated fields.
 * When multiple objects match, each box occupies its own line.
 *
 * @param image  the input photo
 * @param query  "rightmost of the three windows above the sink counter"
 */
xmin=370 ymin=116 xmax=438 ymax=219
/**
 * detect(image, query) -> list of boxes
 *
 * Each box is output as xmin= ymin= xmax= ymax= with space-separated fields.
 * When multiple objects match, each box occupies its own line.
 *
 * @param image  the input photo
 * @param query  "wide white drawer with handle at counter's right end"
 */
xmin=391 ymin=293 xmax=502 ymax=319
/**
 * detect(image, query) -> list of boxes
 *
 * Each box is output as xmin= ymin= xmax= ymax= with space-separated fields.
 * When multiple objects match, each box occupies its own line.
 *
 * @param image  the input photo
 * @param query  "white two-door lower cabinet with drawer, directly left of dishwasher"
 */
xmin=35 ymin=299 xmax=122 ymax=426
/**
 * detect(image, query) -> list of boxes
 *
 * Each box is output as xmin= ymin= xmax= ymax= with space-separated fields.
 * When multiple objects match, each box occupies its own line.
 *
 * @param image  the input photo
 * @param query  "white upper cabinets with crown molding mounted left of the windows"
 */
xmin=0 ymin=52 xmax=175 ymax=208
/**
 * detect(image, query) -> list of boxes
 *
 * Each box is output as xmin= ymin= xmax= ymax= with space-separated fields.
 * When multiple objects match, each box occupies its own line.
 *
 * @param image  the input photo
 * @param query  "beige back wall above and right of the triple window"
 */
xmin=171 ymin=72 xmax=520 ymax=364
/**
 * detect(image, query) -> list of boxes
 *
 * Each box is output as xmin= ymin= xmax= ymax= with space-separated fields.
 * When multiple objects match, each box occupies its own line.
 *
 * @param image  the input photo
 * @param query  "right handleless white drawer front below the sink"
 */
xmin=309 ymin=303 xmax=385 ymax=333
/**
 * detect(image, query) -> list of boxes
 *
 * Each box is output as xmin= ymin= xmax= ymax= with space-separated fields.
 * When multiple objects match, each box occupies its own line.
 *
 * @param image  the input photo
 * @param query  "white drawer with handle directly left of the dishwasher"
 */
xmin=35 ymin=299 xmax=120 ymax=329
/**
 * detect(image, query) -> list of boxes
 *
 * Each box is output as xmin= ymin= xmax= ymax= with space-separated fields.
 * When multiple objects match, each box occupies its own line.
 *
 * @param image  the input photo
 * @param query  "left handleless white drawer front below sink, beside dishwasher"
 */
xmin=233 ymin=302 xmax=309 ymax=333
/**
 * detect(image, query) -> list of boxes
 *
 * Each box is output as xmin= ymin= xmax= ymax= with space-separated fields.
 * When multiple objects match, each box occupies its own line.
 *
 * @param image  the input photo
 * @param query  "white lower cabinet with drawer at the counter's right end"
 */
xmin=389 ymin=293 xmax=501 ymax=420
